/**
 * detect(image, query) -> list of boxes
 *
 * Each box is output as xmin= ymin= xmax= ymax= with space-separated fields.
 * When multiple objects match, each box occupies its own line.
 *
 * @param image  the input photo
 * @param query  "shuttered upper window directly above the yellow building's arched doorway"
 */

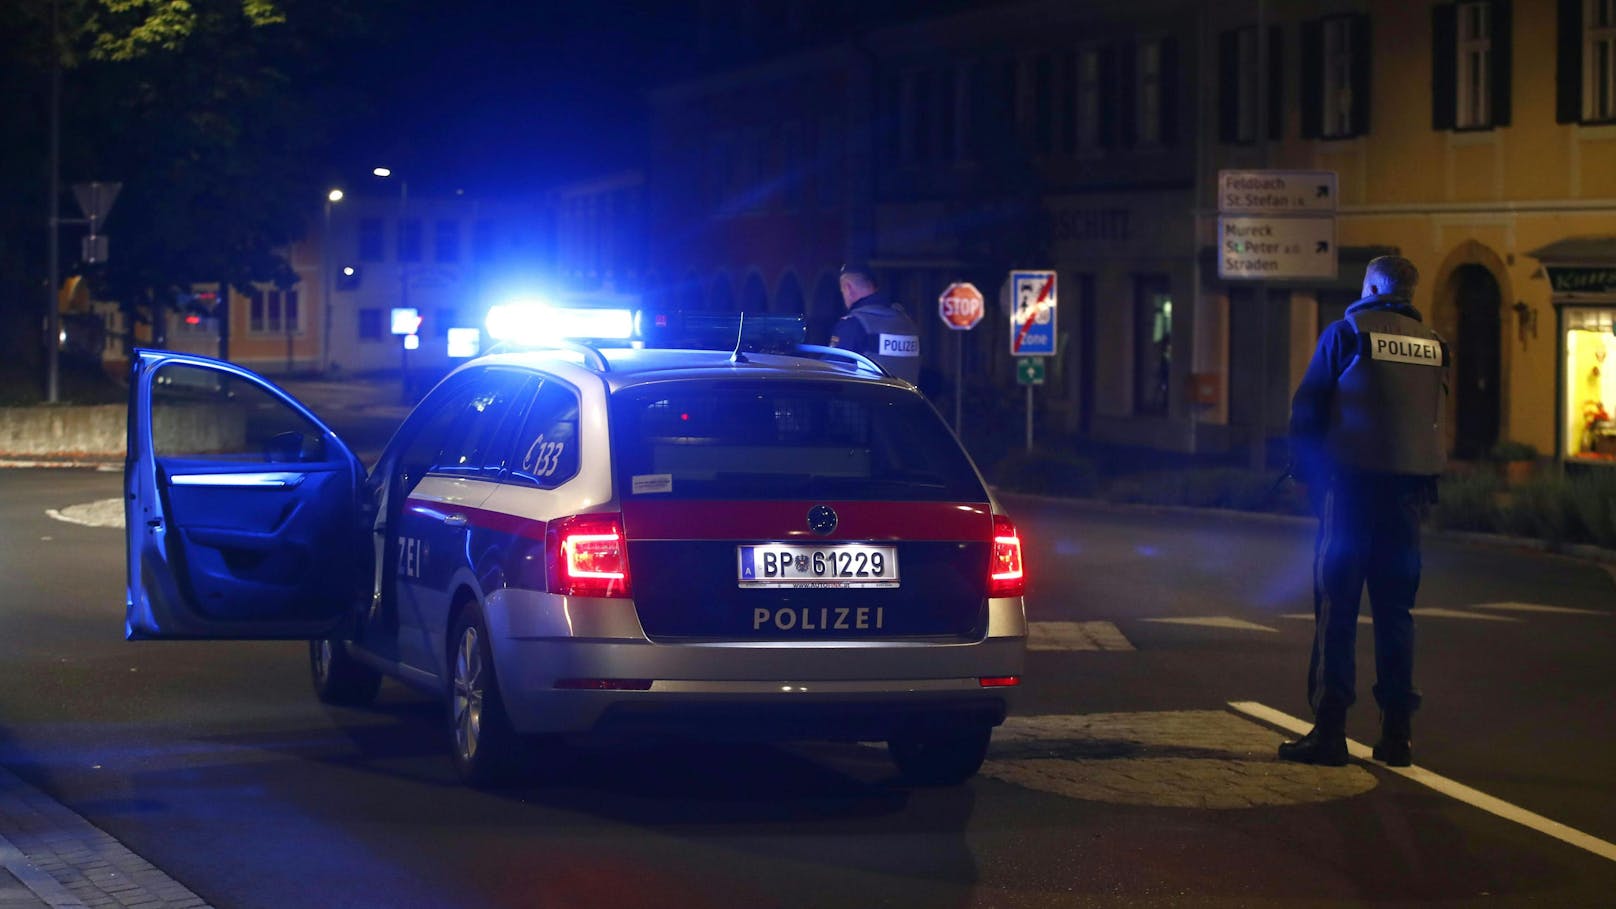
xmin=1430 ymin=0 xmax=1509 ymax=129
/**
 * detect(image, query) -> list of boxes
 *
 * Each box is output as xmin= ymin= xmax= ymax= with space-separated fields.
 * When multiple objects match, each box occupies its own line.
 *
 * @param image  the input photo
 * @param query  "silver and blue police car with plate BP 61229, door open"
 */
xmin=124 ymin=305 xmax=1026 ymax=784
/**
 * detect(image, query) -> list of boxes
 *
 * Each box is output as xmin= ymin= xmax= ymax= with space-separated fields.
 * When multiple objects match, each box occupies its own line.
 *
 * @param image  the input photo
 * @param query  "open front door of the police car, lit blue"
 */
xmin=123 ymin=349 xmax=368 ymax=641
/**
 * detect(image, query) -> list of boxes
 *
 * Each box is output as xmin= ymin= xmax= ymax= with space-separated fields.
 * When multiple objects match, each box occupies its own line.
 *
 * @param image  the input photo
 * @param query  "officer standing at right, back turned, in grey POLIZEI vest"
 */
xmin=1280 ymin=256 xmax=1448 ymax=767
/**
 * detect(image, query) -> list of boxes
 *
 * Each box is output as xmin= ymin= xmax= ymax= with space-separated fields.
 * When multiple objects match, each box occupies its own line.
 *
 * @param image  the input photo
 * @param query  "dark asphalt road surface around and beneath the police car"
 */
xmin=0 ymin=459 xmax=1616 ymax=907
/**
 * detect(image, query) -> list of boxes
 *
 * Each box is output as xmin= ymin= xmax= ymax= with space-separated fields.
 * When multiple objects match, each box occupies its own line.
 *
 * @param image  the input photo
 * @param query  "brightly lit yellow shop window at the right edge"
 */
xmin=1566 ymin=309 xmax=1616 ymax=463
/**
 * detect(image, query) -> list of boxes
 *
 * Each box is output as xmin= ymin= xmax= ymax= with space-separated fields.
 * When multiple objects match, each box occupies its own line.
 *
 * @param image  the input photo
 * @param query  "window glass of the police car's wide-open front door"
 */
xmin=152 ymin=362 xmax=326 ymax=463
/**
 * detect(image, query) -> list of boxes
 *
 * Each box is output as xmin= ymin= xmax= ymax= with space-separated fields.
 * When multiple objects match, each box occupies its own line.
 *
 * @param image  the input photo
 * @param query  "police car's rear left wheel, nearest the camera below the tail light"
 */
xmin=449 ymin=603 xmax=522 ymax=788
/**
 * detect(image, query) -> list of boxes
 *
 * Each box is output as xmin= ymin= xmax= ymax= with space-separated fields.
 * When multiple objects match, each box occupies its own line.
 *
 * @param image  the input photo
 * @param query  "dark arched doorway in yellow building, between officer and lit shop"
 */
xmin=1453 ymin=265 xmax=1503 ymax=458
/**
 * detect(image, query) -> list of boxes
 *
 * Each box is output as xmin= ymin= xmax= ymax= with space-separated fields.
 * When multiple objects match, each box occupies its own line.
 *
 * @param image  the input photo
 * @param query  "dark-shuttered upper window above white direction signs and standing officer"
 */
xmin=1301 ymin=16 xmax=1369 ymax=139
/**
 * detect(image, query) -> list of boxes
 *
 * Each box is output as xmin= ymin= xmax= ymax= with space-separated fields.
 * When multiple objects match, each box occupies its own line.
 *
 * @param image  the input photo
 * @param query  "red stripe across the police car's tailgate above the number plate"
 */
xmin=622 ymin=500 xmax=994 ymax=542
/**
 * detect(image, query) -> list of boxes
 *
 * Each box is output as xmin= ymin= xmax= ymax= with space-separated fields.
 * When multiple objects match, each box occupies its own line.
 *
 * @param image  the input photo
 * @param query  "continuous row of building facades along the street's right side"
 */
xmin=651 ymin=0 xmax=1616 ymax=463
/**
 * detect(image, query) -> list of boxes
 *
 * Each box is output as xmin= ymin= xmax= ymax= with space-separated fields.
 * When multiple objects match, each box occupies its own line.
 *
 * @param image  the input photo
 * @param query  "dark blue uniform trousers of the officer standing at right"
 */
xmin=1307 ymin=474 xmax=1430 ymax=715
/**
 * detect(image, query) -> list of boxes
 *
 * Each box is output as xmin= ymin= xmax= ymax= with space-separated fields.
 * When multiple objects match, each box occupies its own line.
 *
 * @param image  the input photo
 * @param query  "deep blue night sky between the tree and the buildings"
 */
xmin=338 ymin=0 xmax=693 ymax=192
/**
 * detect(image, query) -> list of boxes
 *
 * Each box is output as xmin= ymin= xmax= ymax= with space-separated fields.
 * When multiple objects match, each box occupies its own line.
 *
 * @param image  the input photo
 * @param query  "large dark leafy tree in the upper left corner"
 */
xmin=0 ymin=0 xmax=387 ymax=394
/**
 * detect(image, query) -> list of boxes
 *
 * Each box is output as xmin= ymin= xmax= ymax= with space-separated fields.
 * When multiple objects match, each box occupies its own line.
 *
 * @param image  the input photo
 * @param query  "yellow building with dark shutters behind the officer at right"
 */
xmin=1196 ymin=0 xmax=1616 ymax=464
